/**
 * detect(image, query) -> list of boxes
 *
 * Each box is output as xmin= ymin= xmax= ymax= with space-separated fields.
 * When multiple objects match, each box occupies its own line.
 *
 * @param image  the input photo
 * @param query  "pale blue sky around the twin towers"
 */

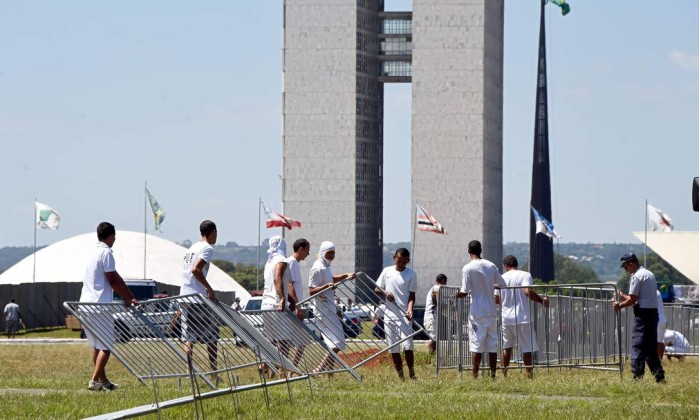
xmin=0 ymin=0 xmax=699 ymax=247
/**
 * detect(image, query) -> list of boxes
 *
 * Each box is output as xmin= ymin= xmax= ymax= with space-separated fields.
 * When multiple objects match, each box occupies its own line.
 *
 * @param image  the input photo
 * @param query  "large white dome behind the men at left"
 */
xmin=0 ymin=230 xmax=250 ymax=301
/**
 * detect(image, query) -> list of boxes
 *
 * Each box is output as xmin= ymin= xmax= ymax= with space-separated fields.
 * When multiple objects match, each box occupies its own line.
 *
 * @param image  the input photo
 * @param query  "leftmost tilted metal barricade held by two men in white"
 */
xmin=64 ymin=295 xmax=302 ymax=388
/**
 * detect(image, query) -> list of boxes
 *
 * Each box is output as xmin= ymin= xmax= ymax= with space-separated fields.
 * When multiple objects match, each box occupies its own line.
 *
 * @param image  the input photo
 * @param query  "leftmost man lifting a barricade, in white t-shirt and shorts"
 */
xmin=80 ymin=222 xmax=138 ymax=391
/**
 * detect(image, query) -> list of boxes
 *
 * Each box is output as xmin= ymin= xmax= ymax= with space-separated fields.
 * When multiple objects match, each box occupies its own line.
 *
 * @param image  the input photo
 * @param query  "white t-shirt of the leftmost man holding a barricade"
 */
xmin=80 ymin=242 xmax=116 ymax=303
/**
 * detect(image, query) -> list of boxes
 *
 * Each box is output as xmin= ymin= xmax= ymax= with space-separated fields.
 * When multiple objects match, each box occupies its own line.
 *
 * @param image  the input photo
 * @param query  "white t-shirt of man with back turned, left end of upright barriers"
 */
xmin=461 ymin=259 xmax=507 ymax=318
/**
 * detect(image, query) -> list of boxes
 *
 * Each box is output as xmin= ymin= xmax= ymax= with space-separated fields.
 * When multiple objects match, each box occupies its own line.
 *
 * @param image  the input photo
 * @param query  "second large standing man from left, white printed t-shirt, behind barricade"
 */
xmin=180 ymin=220 xmax=219 ymax=380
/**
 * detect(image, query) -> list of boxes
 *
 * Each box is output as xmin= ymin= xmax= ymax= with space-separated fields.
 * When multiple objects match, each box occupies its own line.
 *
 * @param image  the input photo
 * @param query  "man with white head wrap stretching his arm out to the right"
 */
xmin=308 ymin=241 xmax=355 ymax=371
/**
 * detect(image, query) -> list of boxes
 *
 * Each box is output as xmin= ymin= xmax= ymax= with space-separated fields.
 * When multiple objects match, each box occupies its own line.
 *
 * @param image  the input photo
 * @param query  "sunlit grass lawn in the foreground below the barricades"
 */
xmin=0 ymin=344 xmax=699 ymax=419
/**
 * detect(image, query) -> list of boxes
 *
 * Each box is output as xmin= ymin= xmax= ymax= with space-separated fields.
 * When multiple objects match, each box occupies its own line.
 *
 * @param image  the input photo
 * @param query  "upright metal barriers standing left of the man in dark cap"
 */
xmin=435 ymin=284 xmax=631 ymax=374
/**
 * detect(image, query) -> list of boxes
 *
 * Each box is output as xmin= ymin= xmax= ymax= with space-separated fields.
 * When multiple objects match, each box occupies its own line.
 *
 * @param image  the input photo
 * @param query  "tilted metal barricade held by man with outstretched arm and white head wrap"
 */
xmin=290 ymin=272 xmax=424 ymax=369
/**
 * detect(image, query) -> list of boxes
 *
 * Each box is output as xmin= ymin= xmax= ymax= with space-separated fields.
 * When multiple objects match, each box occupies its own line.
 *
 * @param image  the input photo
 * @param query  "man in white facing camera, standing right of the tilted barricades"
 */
xmin=376 ymin=248 xmax=417 ymax=379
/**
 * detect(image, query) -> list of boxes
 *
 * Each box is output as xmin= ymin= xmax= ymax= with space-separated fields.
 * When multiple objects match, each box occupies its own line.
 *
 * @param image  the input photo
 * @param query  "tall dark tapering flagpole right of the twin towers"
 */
xmin=527 ymin=0 xmax=554 ymax=283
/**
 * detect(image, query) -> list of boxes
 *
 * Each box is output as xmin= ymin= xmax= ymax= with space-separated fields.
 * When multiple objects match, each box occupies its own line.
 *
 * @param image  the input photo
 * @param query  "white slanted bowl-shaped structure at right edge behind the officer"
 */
xmin=633 ymin=232 xmax=699 ymax=284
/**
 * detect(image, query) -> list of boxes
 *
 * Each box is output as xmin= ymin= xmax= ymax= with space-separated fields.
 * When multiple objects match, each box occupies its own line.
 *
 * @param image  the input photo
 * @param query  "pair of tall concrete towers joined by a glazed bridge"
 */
xmin=282 ymin=0 xmax=503 ymax=304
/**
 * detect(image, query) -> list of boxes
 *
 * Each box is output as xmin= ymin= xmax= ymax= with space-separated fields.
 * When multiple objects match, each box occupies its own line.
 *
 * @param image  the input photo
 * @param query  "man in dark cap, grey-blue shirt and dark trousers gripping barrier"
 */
xmin=612 ymin=253 xmax=665 ymax=382
